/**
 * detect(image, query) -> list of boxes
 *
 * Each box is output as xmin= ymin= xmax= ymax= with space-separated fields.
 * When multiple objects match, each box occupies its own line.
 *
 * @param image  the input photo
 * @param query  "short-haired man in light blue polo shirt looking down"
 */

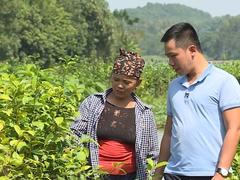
xmin=156 ymin=23 xmax=240 ymax=180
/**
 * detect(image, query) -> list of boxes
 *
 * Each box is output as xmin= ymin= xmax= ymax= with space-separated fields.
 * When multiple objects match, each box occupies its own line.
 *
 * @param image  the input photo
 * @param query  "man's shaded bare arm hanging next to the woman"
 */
xmin=155 ymin=116 xmax=172 ymax=179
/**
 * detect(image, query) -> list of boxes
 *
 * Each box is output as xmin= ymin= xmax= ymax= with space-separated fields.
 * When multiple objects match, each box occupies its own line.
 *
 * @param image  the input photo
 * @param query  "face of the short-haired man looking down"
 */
xmin=165 ymin=39 xmax=192 ymax=75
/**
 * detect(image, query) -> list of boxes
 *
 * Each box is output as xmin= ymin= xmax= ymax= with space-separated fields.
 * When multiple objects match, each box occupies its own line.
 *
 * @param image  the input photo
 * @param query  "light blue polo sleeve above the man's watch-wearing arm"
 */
xmin=219 ymin=75 xmax=240 ymax=112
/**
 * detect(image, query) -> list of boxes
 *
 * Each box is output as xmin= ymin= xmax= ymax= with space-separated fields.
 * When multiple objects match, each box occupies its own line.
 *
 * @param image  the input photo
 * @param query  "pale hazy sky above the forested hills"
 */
xmin=107 ymin=0 xmax=240 ymax=16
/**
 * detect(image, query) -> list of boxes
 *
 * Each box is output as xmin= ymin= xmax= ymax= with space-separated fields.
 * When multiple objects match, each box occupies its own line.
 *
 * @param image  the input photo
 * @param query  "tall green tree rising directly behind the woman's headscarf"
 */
xmin=58 ymin=0 xmax=116 ymax=57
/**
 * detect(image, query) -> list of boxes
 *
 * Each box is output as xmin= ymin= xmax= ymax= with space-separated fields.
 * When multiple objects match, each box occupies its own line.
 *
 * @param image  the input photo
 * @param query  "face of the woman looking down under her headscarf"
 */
xmin=111 ymin=73 xmax=140 ymax=99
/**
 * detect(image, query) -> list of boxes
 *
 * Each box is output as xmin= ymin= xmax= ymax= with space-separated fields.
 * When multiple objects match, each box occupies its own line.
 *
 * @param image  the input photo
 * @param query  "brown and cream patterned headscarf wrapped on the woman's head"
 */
xmin=113 ymin=48 xmax=145 ymax=78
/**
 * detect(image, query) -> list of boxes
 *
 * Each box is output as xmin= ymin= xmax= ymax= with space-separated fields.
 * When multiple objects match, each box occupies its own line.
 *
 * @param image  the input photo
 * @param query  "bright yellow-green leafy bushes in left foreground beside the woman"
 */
xmin=0 ymin=61 xmax=105 ymax=179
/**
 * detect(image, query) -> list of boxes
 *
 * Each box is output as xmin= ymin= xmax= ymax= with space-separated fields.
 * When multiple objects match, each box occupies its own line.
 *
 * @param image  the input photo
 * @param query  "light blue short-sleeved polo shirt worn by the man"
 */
xmin=165 ymin=64 xmax=240 ymax=176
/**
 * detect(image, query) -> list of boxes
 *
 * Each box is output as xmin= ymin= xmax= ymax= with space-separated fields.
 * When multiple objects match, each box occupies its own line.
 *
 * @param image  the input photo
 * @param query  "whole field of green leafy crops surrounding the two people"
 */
xmin=0 ymin=59 xmax=240 ymax=180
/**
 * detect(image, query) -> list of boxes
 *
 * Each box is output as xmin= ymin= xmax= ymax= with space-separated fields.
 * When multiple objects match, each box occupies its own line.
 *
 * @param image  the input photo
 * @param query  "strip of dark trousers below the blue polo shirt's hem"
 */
xmin=163 ymin=173 xmax=212 ymax=180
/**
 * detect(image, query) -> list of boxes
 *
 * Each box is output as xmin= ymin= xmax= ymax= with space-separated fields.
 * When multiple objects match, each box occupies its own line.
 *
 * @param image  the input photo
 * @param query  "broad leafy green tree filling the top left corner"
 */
xmin=0 ymin=0 xmax=76 ymax=67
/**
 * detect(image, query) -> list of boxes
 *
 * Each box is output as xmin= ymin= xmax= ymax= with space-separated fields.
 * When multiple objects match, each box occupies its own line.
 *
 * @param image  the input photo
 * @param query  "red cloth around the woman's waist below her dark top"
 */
xmin=98 ymin=139 xmax=136 ymax=175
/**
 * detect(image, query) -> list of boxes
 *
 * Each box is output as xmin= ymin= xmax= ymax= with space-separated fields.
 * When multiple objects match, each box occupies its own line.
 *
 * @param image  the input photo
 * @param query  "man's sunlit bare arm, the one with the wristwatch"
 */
xmin=213 ymin=107 xmax=240 ymax=180
